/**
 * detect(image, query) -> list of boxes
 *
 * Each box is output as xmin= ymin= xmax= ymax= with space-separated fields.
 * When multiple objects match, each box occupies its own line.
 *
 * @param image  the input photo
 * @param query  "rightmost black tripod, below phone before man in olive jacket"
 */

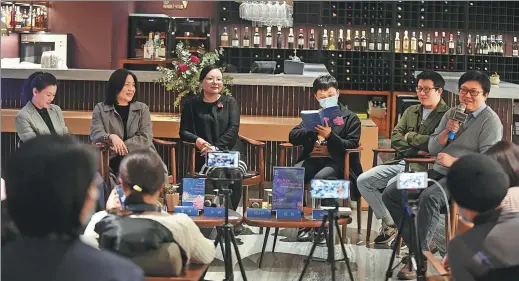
xmin=386 ymin=196 xmax=425 ymax=281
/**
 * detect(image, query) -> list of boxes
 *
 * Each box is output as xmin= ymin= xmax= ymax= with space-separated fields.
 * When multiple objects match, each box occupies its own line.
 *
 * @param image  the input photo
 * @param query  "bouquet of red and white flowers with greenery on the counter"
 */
xmin=155 ymin=42 xmax=232 ymax=106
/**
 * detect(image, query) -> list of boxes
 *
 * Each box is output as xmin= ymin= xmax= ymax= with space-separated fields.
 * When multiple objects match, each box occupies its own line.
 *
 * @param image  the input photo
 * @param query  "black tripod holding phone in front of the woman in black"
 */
xmin=211 ymin=168 xmax=247 ymax=281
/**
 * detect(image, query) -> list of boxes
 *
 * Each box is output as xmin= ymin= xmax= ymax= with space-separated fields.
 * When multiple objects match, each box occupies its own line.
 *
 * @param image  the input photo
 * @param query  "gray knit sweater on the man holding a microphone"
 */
xmin=429 ymin=106 xmax=503 ymax=175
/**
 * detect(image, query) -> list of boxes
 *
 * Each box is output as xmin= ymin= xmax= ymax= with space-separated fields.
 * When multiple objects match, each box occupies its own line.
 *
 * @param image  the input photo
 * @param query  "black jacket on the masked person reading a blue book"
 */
xmin=288 ymin=104 xmax=362 ymax=200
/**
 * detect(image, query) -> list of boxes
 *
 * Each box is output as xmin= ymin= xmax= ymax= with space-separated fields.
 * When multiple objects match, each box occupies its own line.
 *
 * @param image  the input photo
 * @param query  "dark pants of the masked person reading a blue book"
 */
xmin=294 ymin=157 xmax=343 ymax=206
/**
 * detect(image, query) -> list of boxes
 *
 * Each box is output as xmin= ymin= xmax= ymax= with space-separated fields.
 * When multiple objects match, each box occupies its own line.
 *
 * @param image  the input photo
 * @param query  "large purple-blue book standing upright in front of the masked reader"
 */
xmin=272 ymin=167 xmax=305 ymax=211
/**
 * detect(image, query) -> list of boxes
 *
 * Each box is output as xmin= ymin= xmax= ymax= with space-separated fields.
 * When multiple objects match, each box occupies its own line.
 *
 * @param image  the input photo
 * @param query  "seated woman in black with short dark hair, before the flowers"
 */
xmin=180 ymin=65 xmax=247 ymax=210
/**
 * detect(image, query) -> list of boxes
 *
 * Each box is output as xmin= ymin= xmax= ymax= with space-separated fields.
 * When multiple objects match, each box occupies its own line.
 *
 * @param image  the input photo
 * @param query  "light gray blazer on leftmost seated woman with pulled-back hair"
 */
xmin=14 ymin=101 xmax=68 ymax=142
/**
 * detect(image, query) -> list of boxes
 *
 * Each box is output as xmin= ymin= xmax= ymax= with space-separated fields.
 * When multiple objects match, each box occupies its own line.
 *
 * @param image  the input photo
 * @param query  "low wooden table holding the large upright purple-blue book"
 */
xmin=243 ymin=207 xmax=352 ymax=268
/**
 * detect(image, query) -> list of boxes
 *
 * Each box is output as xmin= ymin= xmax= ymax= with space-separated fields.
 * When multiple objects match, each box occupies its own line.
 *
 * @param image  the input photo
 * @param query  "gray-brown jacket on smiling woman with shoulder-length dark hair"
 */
xmin=90 ymin=101 xmax=156 ymax=152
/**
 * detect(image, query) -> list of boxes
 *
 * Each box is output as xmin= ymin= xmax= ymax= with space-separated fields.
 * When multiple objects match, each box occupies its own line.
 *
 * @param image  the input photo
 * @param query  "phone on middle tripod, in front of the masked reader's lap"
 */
xmin=310 ymin=180 xmax=350 ymax=199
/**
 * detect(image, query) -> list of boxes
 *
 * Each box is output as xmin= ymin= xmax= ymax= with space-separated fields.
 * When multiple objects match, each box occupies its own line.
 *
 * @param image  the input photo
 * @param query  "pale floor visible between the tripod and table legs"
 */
xmin=205 ymin=202 xmax=441 ymax=281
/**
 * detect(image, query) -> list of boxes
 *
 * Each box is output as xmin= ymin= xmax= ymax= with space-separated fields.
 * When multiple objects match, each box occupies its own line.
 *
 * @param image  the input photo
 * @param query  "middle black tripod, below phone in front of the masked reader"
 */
xmin=299 ymin=202 xmax=354 ymax=281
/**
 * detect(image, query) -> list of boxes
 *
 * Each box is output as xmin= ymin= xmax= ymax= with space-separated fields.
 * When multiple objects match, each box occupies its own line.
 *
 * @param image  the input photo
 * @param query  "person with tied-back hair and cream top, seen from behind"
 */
xmin=83 ymin=149 xmax=215 ymax=273
